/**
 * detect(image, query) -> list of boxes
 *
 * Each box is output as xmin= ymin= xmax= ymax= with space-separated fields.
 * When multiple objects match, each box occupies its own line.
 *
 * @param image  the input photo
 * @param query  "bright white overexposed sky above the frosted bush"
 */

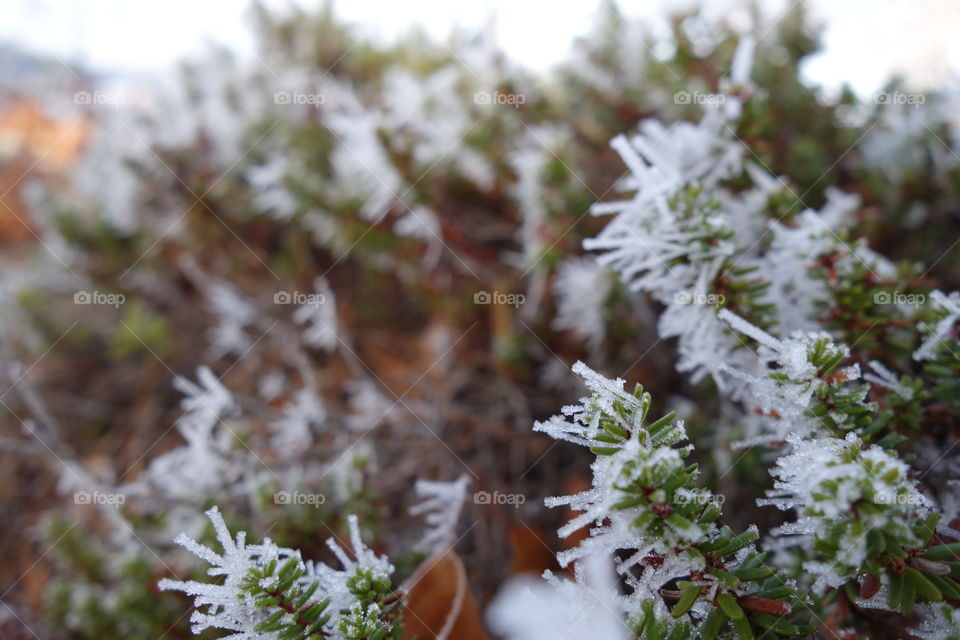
xmin=0 ymin=0 xmax=960 ymax=94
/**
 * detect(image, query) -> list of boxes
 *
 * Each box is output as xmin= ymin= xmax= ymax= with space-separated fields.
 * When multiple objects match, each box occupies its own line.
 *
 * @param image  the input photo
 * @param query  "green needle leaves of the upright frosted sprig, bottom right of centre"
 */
xmin=568 ymin=372 xmax=812 ymax=640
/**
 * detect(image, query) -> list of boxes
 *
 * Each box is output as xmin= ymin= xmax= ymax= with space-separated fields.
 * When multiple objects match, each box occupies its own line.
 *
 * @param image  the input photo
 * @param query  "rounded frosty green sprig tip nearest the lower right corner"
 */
xmin=765 ymin=433 xmax=944 ymax=592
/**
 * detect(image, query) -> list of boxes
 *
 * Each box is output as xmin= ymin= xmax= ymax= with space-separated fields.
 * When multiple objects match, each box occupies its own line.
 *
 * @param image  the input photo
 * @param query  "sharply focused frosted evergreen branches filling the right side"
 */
xmin=495 ymin=27 xmax=960 ymax=638
